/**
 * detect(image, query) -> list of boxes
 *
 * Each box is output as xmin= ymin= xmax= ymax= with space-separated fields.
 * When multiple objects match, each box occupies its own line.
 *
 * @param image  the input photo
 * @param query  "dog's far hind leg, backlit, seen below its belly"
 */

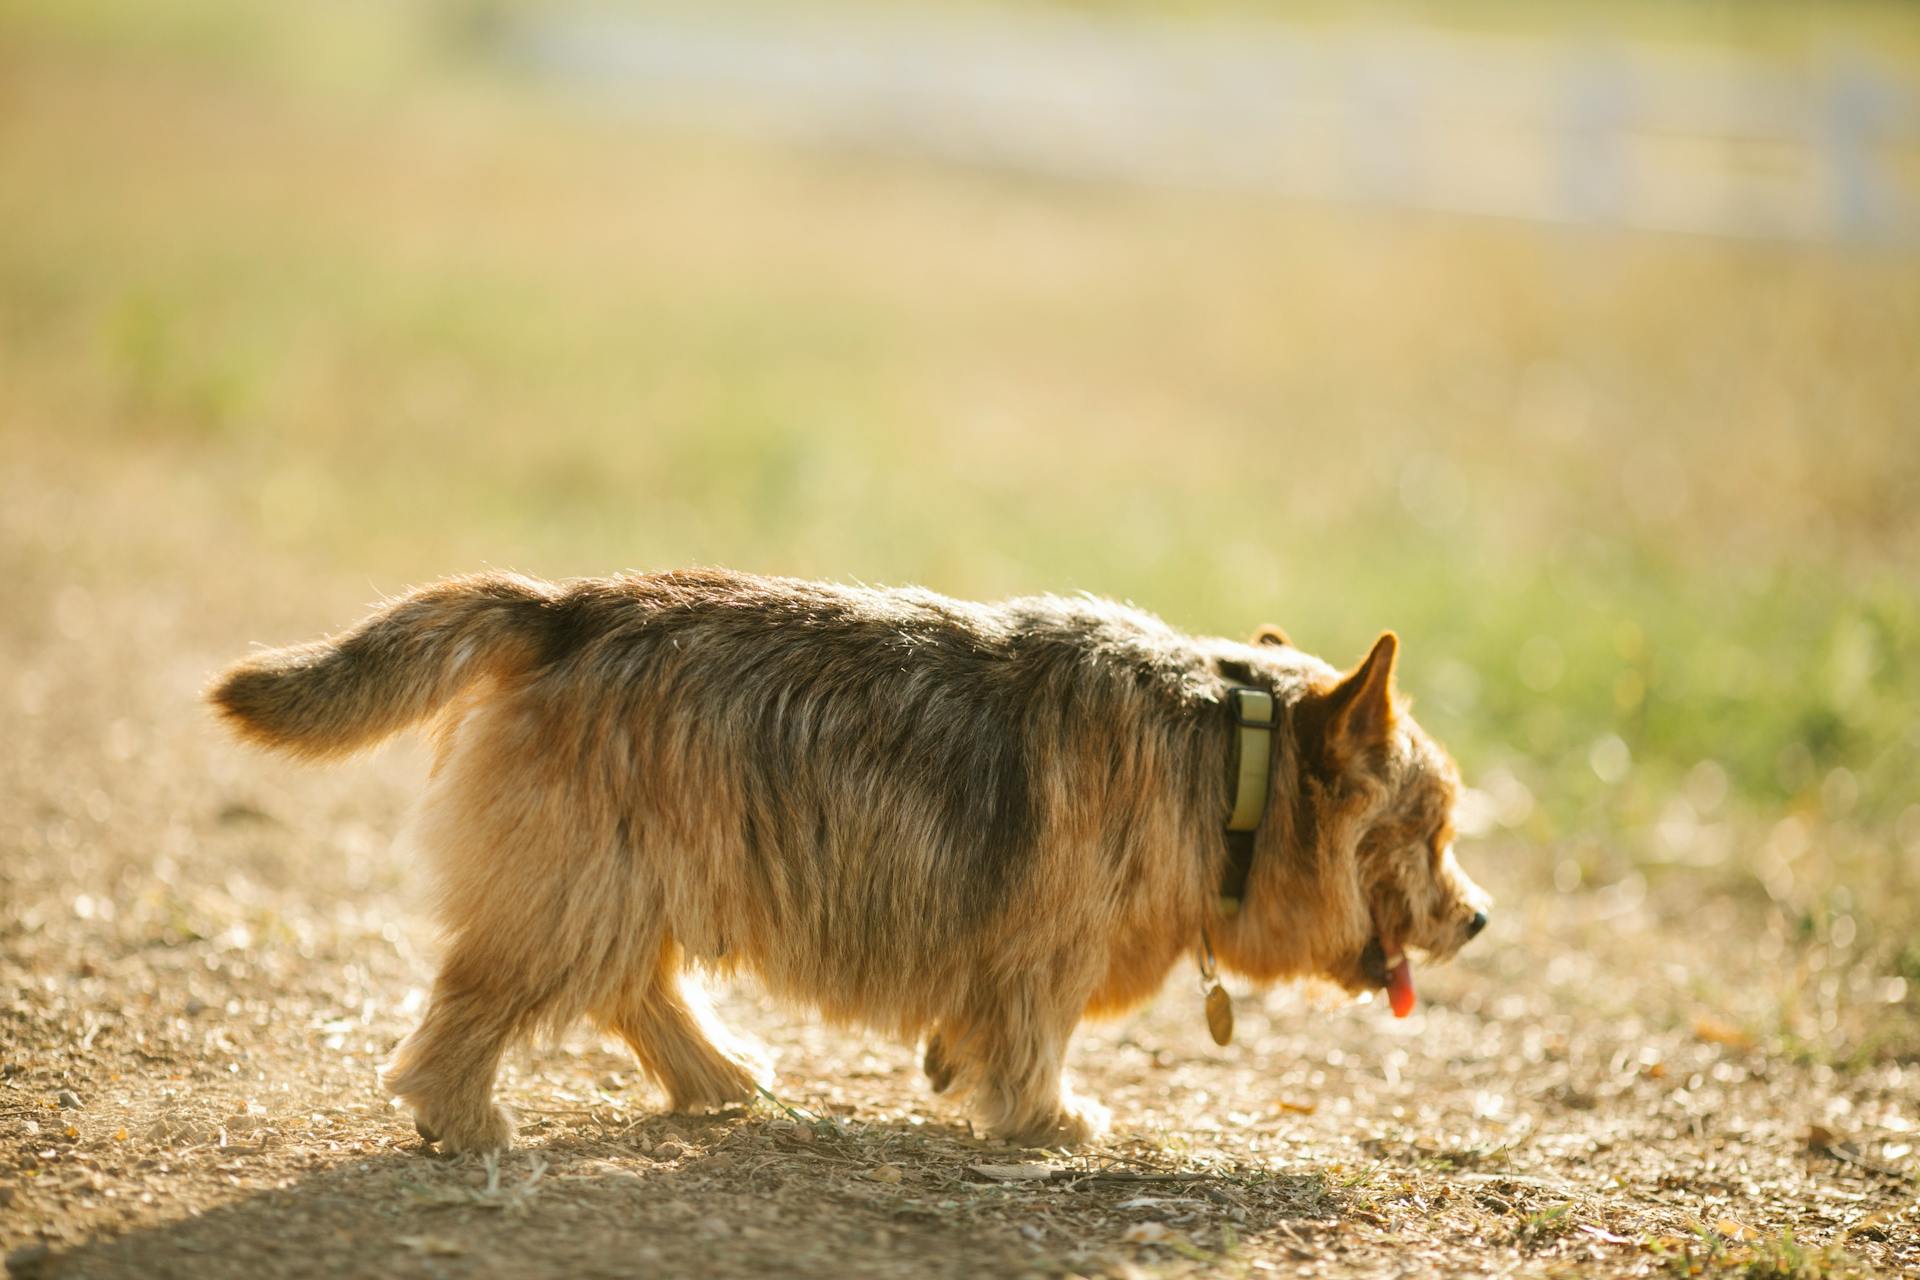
xmin=593 ymin=938 xmax=768 ymax=1111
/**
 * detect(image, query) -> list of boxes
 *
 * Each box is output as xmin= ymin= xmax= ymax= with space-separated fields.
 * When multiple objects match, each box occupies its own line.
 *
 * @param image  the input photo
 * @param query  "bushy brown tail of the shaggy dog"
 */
xmin=207 ymin=574 xmax=564 ymax=760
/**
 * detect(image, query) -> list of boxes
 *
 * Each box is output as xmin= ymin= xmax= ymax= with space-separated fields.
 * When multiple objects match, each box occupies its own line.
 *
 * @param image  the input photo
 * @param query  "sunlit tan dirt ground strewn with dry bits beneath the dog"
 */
xmin=0 ymin=462 xmax=1920 ymax=1278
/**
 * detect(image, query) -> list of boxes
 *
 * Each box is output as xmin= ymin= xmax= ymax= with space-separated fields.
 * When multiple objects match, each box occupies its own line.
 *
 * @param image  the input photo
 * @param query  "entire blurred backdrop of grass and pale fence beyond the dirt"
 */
xmin=0 ymin=0 xmax=1920 ymax=1055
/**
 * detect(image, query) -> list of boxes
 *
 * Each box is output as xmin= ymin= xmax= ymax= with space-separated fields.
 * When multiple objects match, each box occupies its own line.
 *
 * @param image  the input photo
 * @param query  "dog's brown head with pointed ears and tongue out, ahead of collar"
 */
xmin=1236 ymin=628 xmax=1492 ymax=1015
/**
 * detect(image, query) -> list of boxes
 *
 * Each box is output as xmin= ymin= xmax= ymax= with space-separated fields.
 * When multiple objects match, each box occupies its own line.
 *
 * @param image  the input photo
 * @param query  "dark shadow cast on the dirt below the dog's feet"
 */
xmin=42 ymin=1111 xmax=1344 ymax=1280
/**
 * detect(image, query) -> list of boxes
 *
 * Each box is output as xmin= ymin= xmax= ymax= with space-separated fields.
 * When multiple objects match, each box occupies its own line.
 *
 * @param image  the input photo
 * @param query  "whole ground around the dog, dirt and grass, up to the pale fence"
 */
xmin=0 ymin=4 xmax=1920 ymax=1276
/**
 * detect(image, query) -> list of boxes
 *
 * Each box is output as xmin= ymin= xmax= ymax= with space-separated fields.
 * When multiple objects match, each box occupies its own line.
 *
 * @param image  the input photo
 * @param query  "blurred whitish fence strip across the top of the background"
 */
xmin=505 ymin=8 xmax=1920 ymax=244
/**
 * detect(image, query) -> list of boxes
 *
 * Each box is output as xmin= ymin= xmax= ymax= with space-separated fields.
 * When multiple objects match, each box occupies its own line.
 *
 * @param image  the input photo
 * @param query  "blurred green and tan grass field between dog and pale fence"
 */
xmin=0 ymin=0 xmax=1920 ymax=942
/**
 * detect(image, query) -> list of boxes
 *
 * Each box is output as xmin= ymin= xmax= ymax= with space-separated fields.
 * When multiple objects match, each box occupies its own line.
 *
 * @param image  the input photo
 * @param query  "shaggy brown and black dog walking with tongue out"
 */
xmin=209 ymin=570 xmax=1486 ymax=1151
